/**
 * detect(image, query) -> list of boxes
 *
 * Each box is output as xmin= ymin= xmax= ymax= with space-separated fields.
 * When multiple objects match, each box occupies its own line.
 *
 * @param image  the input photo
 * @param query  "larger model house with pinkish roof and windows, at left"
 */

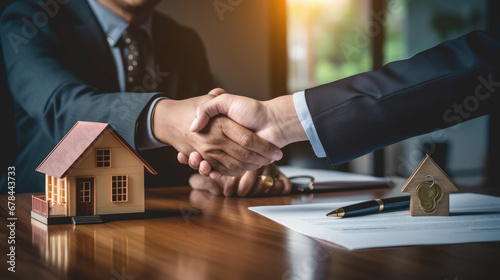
xmin=32 ymin=122 xmax=156 ymax=224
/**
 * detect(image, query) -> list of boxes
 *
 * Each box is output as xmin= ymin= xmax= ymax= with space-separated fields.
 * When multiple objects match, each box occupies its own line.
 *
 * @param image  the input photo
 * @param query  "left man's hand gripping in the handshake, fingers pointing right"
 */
xmin=153 ymin=95 xmax=282 ymax=176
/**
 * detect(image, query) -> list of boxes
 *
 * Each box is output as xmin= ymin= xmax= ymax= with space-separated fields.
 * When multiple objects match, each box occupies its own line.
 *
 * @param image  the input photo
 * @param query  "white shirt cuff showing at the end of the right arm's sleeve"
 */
xmin=293 ymin=91 xmax=326 ymax=158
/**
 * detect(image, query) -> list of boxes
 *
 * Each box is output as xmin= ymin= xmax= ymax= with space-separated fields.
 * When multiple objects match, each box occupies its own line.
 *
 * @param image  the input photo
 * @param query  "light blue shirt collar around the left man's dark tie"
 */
xmin=87 ymin=0 xmax=152 ymax=47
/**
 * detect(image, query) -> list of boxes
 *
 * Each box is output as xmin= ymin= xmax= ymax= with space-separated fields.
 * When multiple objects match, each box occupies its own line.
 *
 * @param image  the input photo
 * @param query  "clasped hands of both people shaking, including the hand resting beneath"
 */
xmin=152 ymin=88 xmax=308 ymax=196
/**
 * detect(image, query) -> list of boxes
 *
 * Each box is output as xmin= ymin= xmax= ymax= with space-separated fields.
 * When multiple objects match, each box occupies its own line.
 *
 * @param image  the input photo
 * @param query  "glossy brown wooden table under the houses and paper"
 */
xmin=0 ymin=187 xmax=500 ymax=280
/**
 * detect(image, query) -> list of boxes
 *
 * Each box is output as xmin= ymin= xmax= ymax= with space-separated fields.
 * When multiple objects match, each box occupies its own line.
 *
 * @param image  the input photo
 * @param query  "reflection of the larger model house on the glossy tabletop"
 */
xmin=31 ymin=219 xmax=146 ymax=279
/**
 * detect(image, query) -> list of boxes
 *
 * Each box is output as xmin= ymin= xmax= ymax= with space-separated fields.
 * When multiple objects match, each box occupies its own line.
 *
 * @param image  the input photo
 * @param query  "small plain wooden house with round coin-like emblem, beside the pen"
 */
xmin=401 ymin=155 xmax=458 ymax=216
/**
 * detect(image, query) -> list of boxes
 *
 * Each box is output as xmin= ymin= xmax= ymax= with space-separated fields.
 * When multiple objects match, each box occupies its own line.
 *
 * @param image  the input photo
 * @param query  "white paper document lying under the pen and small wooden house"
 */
xmin=249 ymin=194 xmax=500 ymax=250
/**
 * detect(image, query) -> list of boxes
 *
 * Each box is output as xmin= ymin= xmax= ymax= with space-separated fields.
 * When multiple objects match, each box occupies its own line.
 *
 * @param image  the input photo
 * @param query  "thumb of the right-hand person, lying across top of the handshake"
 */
xmin=189 ymin=94 xmax=230 ymax=132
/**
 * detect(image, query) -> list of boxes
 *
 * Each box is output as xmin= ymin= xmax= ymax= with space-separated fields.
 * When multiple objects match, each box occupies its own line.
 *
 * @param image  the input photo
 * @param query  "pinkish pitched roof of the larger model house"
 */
xmin=36 ymin=121 xmax=157 ymax=178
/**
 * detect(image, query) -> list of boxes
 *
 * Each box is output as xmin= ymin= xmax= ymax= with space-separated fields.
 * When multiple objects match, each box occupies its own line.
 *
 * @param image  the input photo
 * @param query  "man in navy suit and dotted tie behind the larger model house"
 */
xmin=0 ymin=0 xmax=280 ymax=192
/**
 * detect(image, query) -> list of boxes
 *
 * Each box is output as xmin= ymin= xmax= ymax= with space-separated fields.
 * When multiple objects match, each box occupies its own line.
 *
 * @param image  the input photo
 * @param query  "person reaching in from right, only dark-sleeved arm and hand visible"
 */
xmin=184 ymin=29 xmax=500 ymax=178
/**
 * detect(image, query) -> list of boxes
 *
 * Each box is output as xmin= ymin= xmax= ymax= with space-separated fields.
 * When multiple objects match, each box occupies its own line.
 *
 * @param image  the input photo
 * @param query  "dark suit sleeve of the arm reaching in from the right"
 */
xmin=305 ymin=29 xmax=500 ymax=164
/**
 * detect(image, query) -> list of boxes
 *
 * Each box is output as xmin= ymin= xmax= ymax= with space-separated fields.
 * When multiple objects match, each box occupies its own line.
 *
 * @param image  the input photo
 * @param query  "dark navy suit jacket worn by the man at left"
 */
xmin=0 ymin=0 xmax=213 ymax=192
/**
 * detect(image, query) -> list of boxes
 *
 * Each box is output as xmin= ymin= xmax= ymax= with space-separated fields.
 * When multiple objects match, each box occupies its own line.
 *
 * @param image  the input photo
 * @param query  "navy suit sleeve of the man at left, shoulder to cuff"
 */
xmin=0 ymin=3 xmax=155 ymax=146
